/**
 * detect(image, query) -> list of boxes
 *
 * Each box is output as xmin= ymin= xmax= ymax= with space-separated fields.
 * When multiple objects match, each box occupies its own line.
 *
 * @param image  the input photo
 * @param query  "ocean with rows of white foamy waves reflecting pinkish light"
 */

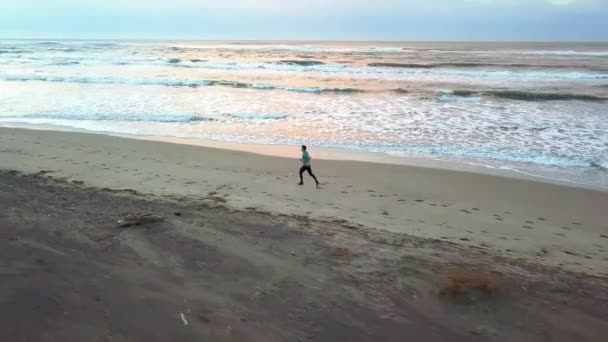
xmin=0 ymin=40 xmax=608 ymax=188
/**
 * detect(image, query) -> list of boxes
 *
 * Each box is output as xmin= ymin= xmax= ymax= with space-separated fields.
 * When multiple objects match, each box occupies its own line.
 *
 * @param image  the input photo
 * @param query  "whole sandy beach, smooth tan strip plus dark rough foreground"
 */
xmin=0 ymin=128 xmax=608 ymax=342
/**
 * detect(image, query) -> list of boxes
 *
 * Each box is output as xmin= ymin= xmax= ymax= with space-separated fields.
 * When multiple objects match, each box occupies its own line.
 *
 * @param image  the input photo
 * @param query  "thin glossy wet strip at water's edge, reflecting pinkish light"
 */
xmin=0 ymin=122 xmax=608 ymax=192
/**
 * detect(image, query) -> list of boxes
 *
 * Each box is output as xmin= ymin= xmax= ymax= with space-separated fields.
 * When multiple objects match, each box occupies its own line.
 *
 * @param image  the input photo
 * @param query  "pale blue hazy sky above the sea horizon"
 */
xmin=0 ymin=0 xmax=608 ymax=41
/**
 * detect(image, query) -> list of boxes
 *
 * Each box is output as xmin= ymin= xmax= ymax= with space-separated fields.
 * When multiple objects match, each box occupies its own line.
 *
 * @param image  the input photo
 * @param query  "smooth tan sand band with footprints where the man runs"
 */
xmin=0 ymin=128 xmax=608 ymax=276
